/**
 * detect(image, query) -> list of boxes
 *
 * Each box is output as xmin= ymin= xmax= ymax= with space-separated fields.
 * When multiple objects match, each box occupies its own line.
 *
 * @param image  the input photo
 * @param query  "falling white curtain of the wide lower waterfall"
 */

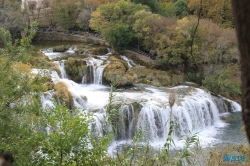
xmin=112 ymin=97 xmax=220 ymax=141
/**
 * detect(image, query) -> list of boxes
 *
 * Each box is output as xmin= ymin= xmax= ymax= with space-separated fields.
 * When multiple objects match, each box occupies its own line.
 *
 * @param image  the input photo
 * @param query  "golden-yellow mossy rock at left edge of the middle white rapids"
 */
xmin=54 ymin=82 xmax=74 ymax=109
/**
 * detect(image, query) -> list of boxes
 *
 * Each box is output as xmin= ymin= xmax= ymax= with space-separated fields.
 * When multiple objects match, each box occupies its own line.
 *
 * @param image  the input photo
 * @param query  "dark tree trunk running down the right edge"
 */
xmin=232 ymin=0 xmax=250 ymax=142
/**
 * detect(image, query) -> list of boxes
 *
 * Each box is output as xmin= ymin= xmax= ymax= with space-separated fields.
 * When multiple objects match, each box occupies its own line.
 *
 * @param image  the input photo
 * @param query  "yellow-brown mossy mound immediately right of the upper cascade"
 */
xmin=103 ymin=56 xmax=133 ymax=87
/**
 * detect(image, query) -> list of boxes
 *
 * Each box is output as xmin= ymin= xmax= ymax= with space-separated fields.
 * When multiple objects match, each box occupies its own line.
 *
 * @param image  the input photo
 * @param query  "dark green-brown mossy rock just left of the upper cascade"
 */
xmin=64 ymin=57 xmax=87 ymax=83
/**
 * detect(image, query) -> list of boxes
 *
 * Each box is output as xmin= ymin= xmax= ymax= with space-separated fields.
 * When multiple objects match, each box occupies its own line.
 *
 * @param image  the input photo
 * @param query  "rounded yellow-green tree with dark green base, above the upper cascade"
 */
xmin=90 ymin=0 xmax=148 ymax=52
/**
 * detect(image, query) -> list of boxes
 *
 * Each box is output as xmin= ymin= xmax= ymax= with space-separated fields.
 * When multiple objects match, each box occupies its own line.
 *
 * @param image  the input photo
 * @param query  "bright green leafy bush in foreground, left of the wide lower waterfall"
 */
xmin=34 ymin=106 xmax=92 ymax=165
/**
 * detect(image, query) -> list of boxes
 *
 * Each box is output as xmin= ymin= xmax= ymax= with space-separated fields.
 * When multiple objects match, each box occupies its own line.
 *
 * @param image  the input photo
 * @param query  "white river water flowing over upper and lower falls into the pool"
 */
xmin=37 ymin=44 xmax=245 ymax=155
